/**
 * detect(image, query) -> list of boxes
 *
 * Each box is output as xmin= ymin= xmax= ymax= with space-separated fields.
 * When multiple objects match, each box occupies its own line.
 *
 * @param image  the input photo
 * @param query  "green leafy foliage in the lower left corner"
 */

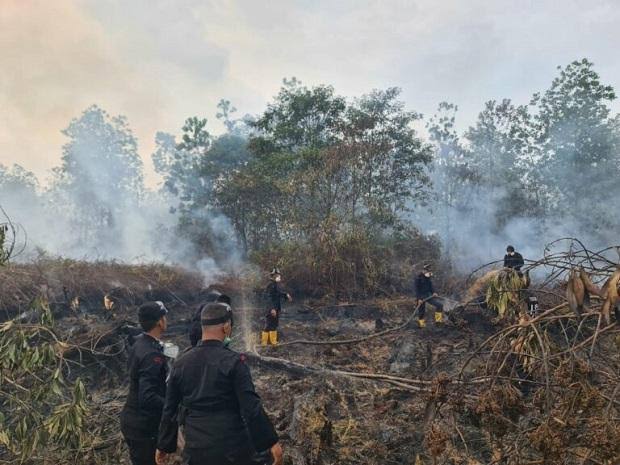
xmin=0 ymin=299 xmax=88 ymax=463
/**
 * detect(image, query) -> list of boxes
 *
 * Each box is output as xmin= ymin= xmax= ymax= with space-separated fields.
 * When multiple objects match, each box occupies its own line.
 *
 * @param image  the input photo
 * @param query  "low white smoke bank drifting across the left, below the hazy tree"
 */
xmin=0 ymin=179 xmax=242 ymax=286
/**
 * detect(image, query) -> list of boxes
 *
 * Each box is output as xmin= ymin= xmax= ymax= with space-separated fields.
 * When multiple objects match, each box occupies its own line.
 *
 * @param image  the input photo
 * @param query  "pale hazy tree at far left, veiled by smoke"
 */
xmin=54 ymin=105 xmax=143 ymax=247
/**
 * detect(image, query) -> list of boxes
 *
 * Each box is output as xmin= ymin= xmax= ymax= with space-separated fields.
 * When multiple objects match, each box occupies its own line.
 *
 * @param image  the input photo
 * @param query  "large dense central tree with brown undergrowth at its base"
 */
xmin=208 ymin=80 xmax=431 ymax=295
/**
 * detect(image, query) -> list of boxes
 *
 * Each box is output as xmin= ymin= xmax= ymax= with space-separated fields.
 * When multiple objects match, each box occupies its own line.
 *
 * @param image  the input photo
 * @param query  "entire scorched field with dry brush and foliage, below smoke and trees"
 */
xmin=0 ymin=237 xmax=620 ymax=465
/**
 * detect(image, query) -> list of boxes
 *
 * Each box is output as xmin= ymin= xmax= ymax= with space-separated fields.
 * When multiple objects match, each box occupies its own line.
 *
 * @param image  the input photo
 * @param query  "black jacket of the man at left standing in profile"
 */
xmin=121 ymin=333 xmax=167 ymax=439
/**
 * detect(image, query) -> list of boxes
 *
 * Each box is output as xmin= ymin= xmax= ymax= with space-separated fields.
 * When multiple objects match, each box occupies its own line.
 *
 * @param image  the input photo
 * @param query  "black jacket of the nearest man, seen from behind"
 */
xmin=157 ymin=340 xmax=278 ymax=455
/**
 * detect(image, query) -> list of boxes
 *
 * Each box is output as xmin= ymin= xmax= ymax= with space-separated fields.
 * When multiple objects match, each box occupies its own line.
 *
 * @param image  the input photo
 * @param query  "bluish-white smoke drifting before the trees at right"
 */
xmin=410 ymin=150 xmax=620 ymax=272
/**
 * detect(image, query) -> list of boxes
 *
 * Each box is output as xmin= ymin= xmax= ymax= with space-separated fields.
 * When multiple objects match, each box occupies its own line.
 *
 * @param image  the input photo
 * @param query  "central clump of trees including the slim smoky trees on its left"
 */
xmin=153 ymin=79 xmax=431 ymax=293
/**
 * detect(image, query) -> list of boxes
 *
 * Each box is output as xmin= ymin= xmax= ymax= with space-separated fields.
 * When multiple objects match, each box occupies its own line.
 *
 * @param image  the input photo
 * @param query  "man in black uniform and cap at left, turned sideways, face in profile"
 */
xmin=121 ymin=302 xmax=168 ymax=465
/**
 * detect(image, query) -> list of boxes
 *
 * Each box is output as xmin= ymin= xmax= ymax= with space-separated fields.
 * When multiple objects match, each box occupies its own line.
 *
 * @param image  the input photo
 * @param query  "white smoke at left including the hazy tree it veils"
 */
xmin=0 ymin=106 xmax=243 ymax=285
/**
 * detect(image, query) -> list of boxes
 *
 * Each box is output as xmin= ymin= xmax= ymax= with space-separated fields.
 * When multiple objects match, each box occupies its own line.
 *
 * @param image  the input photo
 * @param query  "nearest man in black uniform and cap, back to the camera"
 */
xmin=156 ymin=303 xmax=282 ymax=465
